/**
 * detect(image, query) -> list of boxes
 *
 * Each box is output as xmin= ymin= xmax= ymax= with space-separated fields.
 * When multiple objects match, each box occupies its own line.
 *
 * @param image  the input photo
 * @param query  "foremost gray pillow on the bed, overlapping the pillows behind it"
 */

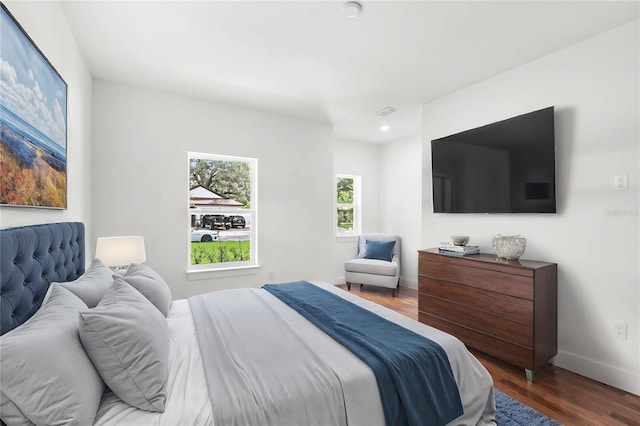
xmin=80 ymin=278 xmax=169 ymax=412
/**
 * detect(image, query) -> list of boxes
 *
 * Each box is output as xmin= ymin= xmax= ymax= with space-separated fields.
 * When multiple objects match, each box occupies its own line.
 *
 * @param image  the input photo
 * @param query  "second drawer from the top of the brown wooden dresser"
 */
xmin=418 ymin=277 xmax=533 ymax=326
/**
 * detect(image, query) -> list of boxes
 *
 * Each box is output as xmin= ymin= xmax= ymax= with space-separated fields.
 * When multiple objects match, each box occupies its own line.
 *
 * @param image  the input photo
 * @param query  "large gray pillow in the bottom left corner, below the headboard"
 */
xmin=0 ymin=286 xmax=104 ymax=425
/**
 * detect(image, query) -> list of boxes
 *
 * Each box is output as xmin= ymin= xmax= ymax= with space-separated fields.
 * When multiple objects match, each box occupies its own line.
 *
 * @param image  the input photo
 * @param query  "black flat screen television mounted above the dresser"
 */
xmin=431 ymin=107 xmax=556 ymax=213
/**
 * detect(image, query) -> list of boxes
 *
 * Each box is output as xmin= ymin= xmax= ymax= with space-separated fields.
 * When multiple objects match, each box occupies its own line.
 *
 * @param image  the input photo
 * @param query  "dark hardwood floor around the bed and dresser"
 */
xmin=338 ymin=285 xmax=640 ymax=426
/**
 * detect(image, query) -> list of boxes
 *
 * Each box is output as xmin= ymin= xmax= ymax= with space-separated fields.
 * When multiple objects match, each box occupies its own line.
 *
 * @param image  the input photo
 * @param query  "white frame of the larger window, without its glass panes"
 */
xmin=186 ymin=152 xmax=259 ymax=274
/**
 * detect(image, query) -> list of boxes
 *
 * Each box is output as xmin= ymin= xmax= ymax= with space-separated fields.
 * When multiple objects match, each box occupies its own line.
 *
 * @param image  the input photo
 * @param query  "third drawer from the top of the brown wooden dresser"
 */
xmin=418 ymin=294 xmax=533 ymax=349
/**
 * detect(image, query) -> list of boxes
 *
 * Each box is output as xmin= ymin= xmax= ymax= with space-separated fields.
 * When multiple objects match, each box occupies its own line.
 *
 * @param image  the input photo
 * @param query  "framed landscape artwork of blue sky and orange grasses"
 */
xmin=0 ymin=3 xmax=67 ymax=209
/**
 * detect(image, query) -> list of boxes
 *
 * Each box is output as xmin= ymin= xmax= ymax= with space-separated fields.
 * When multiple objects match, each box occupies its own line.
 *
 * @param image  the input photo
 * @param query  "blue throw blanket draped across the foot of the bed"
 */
xmin=263 ymin=281 xmax=463 ymax=426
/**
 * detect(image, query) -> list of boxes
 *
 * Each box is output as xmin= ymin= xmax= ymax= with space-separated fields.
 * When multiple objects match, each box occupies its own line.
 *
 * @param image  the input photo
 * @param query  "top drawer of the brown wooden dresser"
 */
xmin=419 ymin=256 xmax=533 ymax=300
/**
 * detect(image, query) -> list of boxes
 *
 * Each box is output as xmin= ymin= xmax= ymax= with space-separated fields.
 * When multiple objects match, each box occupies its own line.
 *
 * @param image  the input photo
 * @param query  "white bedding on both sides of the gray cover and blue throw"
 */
xmin=95 ymin=283 xmax=495 ymax=426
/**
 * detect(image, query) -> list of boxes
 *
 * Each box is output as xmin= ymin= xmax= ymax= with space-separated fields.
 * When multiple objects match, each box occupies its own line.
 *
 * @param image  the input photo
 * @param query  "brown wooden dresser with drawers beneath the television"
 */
xmin=418 ymin=248 xmax=558 ymax=381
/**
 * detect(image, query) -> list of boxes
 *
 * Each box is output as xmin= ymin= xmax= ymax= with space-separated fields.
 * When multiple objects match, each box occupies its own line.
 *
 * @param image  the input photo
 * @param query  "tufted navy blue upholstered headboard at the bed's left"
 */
xmin=0 ymin=222 xmax=85 ymax=334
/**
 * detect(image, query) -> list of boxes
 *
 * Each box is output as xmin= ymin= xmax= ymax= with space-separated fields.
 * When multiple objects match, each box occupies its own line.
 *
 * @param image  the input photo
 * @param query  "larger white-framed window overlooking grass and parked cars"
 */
xmin=187 ymin=152 xmax=258 ymax=271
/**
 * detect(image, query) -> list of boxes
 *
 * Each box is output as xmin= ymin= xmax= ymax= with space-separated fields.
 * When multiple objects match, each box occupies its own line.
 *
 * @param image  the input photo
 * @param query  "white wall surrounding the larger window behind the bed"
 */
xmin=92 ymin=81 xmax=335 ymax=298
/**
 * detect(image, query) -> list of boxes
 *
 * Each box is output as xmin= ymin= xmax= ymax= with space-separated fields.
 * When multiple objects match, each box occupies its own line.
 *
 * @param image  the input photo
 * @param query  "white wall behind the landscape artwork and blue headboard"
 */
xmin=0 ymin=1 xmax=92 ymax=243
